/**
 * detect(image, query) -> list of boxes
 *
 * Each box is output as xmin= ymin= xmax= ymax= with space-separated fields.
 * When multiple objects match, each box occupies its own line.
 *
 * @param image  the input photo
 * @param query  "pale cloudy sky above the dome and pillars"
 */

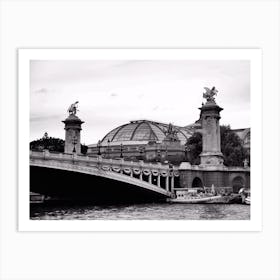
xmin=30 ymin=60 xmax=250 ymax=145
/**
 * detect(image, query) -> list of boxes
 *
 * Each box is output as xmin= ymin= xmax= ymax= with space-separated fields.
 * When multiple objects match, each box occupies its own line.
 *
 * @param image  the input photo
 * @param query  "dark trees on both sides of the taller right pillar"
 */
xmin=186 ymin=125 xmax=246 ymax=166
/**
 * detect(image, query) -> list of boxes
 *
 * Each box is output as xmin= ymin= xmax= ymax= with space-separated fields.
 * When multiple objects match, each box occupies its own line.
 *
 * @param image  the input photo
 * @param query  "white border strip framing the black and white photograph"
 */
xmin=18 ymin=49 xmax=262 ymax=231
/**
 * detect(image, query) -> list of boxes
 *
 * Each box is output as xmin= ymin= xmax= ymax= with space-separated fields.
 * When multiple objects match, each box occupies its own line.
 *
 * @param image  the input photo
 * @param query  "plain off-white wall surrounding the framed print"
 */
xmin=0 ymin=0 xmax=280 ymax=280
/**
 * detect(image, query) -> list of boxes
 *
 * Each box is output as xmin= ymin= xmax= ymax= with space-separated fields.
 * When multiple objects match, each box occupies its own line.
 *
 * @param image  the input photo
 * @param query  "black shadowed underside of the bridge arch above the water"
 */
xmin=30 ymin=164 xmax=170 ymax=203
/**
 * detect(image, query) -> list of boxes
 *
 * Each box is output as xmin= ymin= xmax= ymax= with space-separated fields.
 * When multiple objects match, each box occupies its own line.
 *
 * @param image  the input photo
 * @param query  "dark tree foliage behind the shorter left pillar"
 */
xmin=29 ymin=132 xmax=88 ymax=154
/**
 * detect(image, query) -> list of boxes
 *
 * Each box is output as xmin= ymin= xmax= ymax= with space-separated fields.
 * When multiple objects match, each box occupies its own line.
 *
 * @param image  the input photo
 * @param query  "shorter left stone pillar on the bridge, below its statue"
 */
xmin=62 ymin=114 xmax=84 ymax=154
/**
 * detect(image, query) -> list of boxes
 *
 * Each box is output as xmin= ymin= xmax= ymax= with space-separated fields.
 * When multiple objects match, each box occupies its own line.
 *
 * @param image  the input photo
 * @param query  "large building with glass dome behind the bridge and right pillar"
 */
xmin=87 ymin=120 xmax=250 ymax=165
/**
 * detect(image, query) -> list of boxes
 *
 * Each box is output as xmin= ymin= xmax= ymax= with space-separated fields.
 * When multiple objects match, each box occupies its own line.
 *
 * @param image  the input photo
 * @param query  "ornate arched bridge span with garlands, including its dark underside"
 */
xmin=30 ymin=150 xmax=179 ymax=200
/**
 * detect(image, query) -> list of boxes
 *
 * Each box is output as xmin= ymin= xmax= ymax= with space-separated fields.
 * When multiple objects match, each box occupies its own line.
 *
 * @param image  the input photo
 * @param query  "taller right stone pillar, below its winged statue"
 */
xmin=199 ymin=101 xmax=224 ymax=166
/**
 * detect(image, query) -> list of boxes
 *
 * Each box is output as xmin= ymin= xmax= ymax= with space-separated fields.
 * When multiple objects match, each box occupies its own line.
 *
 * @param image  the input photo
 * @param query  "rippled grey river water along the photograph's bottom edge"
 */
xmin=30 ymin=203 xmax=250 ymax=220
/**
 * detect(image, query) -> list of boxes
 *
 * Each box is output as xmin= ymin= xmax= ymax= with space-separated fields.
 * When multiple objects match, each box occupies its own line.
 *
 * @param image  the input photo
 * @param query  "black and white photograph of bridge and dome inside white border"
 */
xmin=26 ymin=52 xmax=254 ymax=220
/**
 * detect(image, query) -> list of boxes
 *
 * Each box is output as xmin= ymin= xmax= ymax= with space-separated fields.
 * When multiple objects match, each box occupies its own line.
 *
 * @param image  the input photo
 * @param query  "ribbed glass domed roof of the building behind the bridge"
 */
xmin=101 ymin=120 xmax=192 ymax=145
